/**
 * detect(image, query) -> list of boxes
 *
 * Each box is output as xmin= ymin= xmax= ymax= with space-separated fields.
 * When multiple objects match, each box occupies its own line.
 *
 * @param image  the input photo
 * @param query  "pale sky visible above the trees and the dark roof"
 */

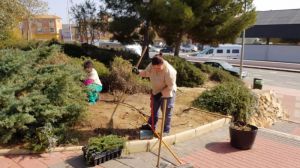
xmin=45 ymin=0 xmax=300 ymax=23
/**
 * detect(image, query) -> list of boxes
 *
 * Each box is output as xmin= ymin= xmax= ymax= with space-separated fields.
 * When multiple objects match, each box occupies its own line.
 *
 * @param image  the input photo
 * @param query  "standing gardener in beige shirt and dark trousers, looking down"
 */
xmin=133 ymin=55 xmax=177 ymax=136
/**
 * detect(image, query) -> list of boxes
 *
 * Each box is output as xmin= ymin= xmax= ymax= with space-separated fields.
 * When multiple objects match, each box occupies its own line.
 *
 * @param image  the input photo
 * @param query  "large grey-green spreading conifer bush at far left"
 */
xmin=0 ymin=46 xmax=87 ymax=150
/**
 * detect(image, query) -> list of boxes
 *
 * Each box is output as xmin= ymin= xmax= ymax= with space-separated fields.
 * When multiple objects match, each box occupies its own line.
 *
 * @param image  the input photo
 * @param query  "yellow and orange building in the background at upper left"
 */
xmin=21 ymin=15 xmax=62 ymax=40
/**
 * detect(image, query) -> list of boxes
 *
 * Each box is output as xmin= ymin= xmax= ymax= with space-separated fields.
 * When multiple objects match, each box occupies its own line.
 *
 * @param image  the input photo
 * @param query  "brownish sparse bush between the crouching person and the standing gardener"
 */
xmin=103 ymin=57 xmax=150 ymax=94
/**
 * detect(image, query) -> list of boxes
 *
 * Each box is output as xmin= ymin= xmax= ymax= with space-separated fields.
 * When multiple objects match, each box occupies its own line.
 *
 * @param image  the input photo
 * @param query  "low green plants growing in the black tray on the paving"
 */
xmin=85 ymin=135 xmax=125 ymax=164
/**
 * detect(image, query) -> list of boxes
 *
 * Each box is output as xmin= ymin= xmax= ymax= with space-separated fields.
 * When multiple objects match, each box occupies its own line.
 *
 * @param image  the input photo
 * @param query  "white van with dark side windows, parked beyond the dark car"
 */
xmin=197 ymin=44 xmax=242 ymax=59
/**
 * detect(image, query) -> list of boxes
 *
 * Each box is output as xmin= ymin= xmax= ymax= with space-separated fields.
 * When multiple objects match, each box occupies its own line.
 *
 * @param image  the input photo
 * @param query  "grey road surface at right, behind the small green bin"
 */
xmin=244 ymin=68 xmax=300 ymax=90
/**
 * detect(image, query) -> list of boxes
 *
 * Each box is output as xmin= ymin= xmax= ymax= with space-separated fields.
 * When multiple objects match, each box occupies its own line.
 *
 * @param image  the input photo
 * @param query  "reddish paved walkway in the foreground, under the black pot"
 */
xmin=0 ymin=126 xmax=300 ymax=168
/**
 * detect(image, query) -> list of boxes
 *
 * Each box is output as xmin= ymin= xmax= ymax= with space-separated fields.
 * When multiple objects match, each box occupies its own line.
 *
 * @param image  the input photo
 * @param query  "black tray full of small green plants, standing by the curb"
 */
xmin=82 ymin=135 xmax=125 ymax=165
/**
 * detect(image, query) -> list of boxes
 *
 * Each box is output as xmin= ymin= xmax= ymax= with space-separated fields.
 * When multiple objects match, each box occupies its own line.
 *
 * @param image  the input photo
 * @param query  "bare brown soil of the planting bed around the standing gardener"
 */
xmin=76 ymin=84 xmax=221 ymax=144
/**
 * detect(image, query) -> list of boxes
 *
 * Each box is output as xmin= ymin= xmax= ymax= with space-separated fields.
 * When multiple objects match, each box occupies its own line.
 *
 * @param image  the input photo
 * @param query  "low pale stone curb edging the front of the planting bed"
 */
xmin=0 ymin=118 xmax=230 ymax=156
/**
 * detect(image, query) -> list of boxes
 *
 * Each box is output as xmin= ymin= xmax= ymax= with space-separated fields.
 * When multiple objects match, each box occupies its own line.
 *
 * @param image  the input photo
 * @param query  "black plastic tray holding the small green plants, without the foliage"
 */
xmin=82 ymin=146 xmax=122 ymax=166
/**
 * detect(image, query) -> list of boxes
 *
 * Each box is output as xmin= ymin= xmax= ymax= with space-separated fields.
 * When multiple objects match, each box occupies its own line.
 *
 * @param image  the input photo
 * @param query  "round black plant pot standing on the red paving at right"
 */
xmin=229 ymin=125 xmax=258 ymax=150
